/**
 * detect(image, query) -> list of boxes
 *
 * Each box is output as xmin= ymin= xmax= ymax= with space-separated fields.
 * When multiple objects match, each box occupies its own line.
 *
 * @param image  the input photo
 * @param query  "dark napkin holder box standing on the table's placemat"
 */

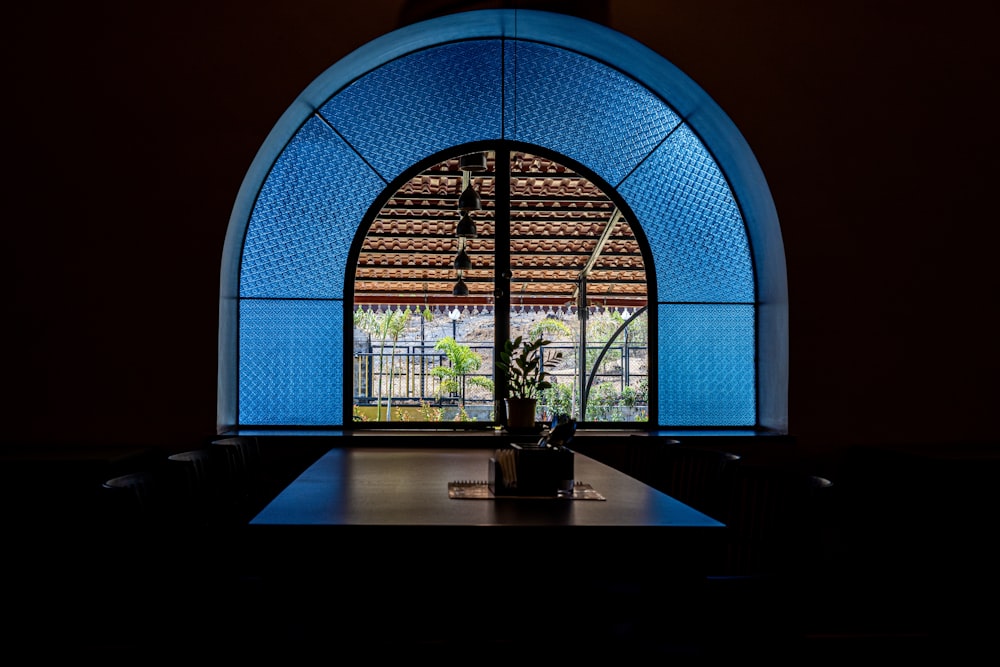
xmin=488 ymin=444 xmax=574 ymax=498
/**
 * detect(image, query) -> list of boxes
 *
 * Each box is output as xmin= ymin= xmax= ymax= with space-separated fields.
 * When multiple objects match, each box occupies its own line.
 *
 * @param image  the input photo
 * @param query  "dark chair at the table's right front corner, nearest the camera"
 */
xmin=700 ymin=459 xmax=834 ymax=657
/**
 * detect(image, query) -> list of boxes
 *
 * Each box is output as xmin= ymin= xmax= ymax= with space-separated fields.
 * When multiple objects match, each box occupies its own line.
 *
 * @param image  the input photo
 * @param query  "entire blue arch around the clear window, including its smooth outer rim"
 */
xmin=219 ymin=10 xmax=787 ymax=432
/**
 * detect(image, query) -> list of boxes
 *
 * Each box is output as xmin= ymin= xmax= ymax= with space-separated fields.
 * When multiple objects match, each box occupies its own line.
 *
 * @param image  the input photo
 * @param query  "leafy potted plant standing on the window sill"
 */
xmin=496 ymin=336 xmax=562 ymax=428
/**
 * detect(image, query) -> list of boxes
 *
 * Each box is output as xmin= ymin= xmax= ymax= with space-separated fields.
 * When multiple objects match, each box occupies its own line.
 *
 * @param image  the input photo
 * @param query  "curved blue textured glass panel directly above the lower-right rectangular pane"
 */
xmin=618 ymin=126 xmax=754 ymax=303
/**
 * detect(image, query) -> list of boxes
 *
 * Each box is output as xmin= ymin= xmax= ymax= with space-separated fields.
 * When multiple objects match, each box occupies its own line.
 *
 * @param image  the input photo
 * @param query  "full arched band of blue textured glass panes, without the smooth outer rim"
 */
xmin=239 ymin=28 xmax=757 ymax=427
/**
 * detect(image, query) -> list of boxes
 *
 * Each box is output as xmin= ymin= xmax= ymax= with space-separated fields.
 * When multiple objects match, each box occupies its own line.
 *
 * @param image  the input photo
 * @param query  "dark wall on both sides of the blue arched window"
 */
xmin=2 ymin=0 xmax=1000 ymax=454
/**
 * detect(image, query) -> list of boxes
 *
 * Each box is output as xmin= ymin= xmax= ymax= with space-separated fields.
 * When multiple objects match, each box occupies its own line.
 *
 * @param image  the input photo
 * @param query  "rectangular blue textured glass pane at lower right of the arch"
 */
xmin=657 ymin=304 xmax=757 ymax=426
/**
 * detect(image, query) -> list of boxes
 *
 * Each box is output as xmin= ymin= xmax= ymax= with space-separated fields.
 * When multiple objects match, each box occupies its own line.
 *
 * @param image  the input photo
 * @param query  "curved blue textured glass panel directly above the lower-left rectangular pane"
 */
xmin=240 ymin=118 xmax=385 ymax=298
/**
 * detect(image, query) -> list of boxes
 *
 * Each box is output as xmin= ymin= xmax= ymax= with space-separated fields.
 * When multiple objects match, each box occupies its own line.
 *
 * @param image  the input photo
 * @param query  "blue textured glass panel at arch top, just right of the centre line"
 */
xmin=505 ymin=42 xmax=680 ymax=185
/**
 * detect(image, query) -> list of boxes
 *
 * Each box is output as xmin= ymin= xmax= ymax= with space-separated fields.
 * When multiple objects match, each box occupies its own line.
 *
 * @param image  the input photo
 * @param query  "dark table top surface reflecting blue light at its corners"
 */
xmin=251 ymin=447 xmax=723 ymax=529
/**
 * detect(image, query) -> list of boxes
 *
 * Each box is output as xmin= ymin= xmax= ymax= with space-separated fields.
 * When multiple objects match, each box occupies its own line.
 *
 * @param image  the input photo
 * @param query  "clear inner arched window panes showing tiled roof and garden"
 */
xmin=352 ymin=152 xmax=650 ymax=427
